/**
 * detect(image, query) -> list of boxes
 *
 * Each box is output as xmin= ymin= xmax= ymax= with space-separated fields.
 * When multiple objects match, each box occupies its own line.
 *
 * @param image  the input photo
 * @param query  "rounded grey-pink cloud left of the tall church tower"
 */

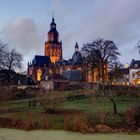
xmin=3 ymin=17 xmax=42 ymax=56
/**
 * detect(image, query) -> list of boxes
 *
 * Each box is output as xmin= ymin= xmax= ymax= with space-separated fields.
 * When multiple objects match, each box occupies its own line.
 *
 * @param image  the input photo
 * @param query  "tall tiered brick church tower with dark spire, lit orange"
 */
xmin=44 ymin=17 xmax=62 ymax=63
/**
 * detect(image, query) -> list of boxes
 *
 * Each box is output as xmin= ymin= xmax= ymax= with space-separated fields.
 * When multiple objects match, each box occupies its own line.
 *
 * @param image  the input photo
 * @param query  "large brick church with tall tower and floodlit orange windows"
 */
xmin=27 ymin=17 xmax=107 ymax=87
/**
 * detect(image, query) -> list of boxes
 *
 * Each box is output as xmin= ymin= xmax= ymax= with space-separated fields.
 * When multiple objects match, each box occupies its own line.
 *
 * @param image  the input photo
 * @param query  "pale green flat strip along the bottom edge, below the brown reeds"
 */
xmin=0 ymin=128 xmax=140 ymax=140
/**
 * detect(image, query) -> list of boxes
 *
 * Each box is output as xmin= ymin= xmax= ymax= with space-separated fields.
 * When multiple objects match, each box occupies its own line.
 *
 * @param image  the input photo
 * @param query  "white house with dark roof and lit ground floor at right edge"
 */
xmin=129 ymin=59 xmax=140 ymax=87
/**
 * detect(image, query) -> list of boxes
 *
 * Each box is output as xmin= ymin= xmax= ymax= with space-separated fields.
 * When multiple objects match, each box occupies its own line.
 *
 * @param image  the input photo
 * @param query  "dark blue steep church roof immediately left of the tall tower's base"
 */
xmin=33 ymin=55 xmax=51 ymax=67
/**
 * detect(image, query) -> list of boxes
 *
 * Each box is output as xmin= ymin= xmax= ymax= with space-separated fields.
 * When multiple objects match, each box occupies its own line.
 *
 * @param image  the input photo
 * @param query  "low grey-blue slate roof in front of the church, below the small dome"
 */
xmin=62 ymin=70 xmax=82 ymax=81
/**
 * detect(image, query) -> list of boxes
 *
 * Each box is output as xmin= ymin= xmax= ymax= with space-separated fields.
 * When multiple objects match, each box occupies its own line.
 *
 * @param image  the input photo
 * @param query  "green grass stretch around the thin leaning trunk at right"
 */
xmin=58 ymin=97 xmax=140 ymax=113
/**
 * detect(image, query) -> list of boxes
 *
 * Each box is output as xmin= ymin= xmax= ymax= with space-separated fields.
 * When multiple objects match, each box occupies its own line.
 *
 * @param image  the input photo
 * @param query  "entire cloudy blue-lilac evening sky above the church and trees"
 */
xmin=0 ymin=0 xmax=140 ymax=71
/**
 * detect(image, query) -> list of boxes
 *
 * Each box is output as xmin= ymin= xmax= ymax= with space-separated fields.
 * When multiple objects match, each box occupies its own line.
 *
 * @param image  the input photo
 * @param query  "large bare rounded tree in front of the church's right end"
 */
xmin=81 ymin=38 xmax=120 ymax=84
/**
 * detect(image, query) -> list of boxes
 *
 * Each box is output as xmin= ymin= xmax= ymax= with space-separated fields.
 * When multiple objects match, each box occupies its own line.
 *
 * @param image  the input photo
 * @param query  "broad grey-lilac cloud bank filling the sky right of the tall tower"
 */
xmin=55 ymin=0 xmax=140 ymax=62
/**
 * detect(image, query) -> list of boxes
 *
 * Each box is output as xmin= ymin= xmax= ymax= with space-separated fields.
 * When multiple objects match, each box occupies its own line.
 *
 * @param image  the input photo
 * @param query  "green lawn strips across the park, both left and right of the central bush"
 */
xmin=2 ymin=93 xmax=140 ymax=116
